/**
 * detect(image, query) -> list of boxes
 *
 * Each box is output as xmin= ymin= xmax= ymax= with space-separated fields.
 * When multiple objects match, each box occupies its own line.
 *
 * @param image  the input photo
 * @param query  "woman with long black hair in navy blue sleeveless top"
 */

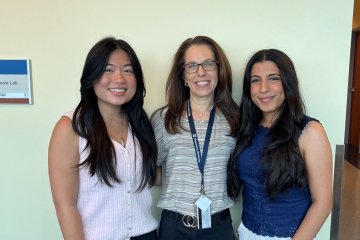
xmin=228 ymin=49 xmax=332 ymax=240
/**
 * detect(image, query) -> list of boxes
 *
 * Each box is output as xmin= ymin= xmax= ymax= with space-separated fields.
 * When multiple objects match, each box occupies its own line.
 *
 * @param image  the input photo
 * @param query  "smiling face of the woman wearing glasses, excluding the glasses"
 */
xmin=184 ymin=45 xmax=218 ymax=99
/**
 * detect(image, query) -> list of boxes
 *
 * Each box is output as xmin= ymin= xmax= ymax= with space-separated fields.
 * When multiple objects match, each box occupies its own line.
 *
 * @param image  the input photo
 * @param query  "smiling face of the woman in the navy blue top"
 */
xmin=250 ymin=61 xmax=285 ymax=125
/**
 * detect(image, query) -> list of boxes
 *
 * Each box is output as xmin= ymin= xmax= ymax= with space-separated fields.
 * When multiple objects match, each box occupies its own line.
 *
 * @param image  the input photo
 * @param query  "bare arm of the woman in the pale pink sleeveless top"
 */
xmin=48 ymin=117 xmax=85 ymax=240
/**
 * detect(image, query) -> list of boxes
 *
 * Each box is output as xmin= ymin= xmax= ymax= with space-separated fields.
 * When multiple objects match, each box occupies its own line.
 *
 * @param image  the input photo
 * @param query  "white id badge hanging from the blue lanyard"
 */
xmin=195 ymin=195 xmax=212 ymax=229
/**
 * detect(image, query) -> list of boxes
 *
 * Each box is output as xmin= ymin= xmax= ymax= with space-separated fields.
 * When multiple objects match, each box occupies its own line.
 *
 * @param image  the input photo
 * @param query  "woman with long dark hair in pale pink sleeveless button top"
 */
xmin=49 ymin=37 xmax=158 ymax=240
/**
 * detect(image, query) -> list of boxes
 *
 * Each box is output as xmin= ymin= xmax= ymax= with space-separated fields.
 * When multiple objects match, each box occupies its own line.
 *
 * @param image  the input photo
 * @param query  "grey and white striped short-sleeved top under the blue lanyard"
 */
xmin=152 ymin=109 xmax=235 ymax=215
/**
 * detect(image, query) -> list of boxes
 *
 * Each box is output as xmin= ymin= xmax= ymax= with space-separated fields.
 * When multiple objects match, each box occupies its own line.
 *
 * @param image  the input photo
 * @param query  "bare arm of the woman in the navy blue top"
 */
xmin=293 ymin=121 xmax=333 ymax=240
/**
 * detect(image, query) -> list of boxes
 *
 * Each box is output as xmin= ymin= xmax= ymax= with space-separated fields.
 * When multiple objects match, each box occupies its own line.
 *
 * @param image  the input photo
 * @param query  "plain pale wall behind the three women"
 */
xmin=0 ymin=0 xmax=353 ymax=240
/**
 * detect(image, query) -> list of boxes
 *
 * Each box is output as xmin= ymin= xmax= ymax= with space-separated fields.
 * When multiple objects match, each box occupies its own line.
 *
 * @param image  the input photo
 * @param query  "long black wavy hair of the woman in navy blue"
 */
xmin=227 ymin=49 xmax=307 ymax=199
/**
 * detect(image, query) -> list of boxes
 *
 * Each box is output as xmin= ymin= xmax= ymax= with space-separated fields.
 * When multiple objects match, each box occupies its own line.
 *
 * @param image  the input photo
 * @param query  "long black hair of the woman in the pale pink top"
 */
xmin=72 ymin=37 xmax=157 ymax=190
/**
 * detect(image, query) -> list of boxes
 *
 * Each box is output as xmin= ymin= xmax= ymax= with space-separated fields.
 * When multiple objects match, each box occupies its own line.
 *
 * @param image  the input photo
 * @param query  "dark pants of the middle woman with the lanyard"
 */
xmin=159 ymin=209 xmax=234 ymax=240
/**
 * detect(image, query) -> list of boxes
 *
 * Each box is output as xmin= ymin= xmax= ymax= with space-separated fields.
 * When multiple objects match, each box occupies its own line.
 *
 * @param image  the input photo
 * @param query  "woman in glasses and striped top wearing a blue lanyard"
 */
xmin=152 ymin=36 xmax=239 ymax=240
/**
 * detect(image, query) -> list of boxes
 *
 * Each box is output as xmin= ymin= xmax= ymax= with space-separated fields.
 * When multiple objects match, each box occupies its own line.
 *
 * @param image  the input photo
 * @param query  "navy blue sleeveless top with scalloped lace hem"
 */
xmin=236 ymin=117 xmax=316 ymax=237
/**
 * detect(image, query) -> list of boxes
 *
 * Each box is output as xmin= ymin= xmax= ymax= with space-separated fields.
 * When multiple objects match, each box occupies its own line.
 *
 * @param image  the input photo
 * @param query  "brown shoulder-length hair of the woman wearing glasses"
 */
xmin=161 ymin=36 xmax=239 ymax=134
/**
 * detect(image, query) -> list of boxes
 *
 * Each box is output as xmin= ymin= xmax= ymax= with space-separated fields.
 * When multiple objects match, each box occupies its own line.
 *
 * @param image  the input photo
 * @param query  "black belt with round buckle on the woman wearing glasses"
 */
xmin=162 ymin=208 xmax=230 ymax=228
